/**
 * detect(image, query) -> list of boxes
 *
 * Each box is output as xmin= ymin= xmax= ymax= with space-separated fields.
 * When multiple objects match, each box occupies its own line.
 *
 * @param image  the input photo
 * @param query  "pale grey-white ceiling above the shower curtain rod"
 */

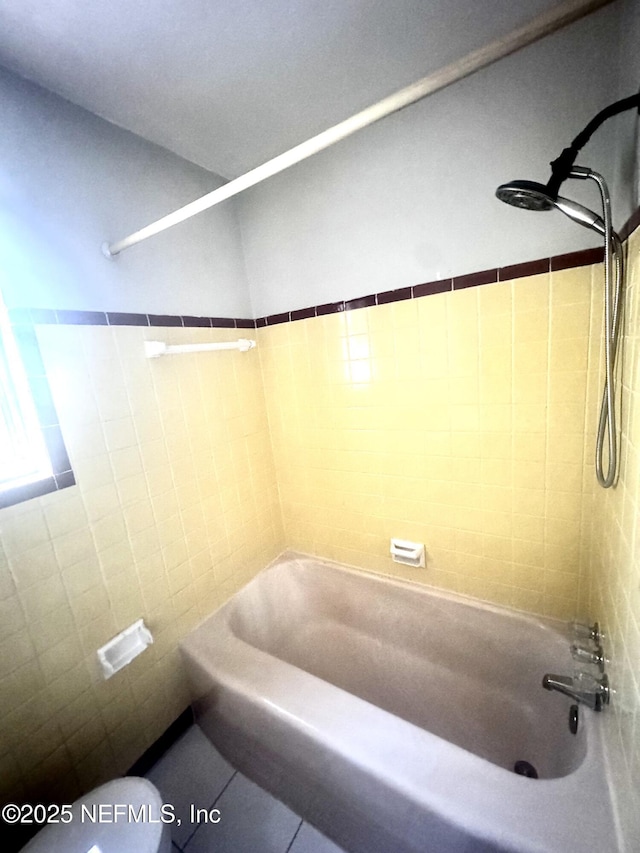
xmin=0 ymin=0 xmax=558 ymax=178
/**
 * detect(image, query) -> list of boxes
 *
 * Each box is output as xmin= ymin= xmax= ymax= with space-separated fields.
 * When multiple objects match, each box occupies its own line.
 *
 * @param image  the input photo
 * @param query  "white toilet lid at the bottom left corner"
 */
xmin=22 ymin=776 xmax=171 ymax=853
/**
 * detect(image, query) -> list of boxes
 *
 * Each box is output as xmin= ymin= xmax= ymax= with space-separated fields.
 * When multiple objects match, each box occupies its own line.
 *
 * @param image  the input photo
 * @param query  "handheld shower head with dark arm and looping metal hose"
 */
xmin=496 ymin=93 xmax=640 ymax=489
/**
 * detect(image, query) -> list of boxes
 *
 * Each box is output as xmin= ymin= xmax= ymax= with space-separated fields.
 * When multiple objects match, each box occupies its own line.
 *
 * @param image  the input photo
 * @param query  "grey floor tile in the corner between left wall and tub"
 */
xmin=147 ymin=726 xmax=235 ymax=847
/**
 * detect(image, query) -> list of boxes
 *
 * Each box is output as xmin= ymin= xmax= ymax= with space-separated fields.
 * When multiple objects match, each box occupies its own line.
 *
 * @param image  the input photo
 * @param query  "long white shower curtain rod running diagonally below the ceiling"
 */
xmin=102 ymin=0 xmax=613 ymax=258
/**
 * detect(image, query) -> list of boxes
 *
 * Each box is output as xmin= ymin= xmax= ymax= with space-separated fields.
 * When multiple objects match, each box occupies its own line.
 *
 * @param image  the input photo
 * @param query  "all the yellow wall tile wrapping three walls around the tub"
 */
xmin=0 ymin=246 xmax=640 ymax=832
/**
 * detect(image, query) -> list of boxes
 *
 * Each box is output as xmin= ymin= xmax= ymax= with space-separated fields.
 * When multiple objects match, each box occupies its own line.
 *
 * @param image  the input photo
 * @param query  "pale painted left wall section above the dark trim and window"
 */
xmin=0 ymin=69 xmax=251 ymax=317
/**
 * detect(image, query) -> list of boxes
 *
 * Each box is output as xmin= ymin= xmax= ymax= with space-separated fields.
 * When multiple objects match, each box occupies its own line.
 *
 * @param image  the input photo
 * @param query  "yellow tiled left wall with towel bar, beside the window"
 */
xmin=0 ymin=326 xmax=284 ymax=802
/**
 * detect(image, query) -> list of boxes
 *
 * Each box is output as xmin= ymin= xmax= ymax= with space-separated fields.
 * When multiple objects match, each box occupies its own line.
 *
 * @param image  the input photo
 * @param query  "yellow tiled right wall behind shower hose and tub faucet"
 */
xmin=580 ymin=230 xmax=640 ymax=850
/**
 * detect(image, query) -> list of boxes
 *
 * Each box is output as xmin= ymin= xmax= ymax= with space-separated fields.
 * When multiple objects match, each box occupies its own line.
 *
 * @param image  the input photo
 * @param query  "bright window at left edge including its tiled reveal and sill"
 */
xmin=0 ymin=297 xmax=75 ymax=507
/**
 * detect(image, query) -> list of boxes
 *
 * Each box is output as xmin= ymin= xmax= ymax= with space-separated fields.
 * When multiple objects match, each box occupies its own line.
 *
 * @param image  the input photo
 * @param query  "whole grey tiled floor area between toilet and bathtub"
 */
xmin=147 ymin=726 xmax=343 ymax=853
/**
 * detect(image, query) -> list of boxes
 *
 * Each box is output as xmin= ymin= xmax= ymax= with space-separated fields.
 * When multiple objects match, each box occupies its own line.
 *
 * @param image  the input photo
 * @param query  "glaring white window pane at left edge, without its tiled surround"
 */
xmin=0 ymin=297 xmax=53 ymax=492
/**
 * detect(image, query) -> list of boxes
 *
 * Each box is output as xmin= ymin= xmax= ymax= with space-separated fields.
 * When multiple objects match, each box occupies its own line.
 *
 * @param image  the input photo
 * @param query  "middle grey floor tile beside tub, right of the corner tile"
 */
xmin=185 ymin=773 xmax=301 ymax=853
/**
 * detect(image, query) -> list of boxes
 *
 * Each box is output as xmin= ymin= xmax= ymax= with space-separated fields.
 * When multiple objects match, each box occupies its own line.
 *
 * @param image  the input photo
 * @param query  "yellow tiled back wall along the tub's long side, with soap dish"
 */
xmin=258 ymin=267 xmax=598 ymax=619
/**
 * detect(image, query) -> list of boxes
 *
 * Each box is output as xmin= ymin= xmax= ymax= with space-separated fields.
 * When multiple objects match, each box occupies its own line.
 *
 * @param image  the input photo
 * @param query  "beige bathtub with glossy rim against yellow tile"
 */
xmin=182 ymin=555 xmax=622 ymax=853
